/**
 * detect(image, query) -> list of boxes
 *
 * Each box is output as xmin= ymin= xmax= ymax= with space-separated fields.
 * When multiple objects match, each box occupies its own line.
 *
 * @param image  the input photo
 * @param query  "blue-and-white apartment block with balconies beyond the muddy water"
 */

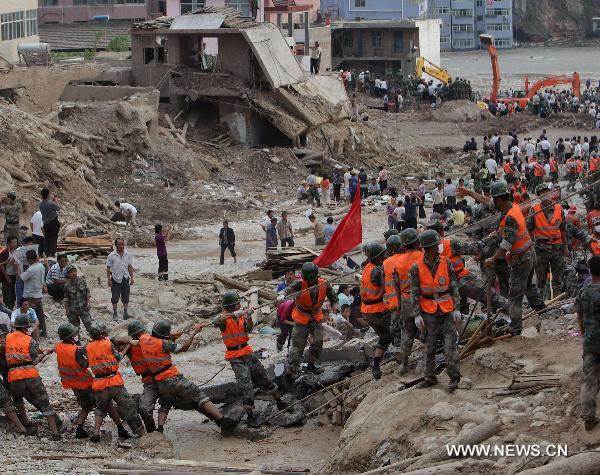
xmin=428 ymin=0 xmax=513 ymax=50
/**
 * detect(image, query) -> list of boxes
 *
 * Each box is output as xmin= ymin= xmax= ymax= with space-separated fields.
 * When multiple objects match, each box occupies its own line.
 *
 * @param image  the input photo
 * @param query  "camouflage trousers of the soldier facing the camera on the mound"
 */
xmin=422 ymin=313 xmax=460 ymax=381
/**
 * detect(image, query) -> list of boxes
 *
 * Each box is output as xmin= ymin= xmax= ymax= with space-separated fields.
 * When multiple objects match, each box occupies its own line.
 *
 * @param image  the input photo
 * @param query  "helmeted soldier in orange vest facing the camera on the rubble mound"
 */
xmin=410 ymin=230 xmax=461 ymax=392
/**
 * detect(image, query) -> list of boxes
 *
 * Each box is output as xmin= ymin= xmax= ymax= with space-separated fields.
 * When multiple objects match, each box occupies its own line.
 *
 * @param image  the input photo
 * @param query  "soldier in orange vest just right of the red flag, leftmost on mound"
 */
xmin=360 ymin=242 xmax=394 ymax=379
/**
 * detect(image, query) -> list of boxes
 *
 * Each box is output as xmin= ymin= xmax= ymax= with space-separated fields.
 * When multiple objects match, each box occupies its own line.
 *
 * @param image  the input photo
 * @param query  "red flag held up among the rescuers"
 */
xmin=313 ymin=183 xmax=362 ymax=267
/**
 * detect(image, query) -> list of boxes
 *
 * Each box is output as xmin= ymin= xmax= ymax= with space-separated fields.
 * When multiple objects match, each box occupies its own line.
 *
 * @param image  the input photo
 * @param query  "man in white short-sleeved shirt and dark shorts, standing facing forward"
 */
xmin=106 ymin=239 xmax=133 ymax=321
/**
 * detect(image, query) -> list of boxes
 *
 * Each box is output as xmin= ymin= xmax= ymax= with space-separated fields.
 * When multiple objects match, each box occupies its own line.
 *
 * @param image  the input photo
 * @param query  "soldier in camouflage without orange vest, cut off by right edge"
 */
xmin=575 ymin=256 xmax=600 ymax=431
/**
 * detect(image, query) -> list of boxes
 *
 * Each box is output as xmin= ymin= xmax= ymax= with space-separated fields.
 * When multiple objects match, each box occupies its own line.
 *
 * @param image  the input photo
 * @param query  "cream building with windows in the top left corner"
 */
xmin=0 ymin=0 xmax=39 ymax=63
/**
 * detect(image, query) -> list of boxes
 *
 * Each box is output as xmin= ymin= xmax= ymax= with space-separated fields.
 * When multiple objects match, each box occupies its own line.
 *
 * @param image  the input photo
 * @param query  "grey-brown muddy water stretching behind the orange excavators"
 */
xmin=441 ymin=46 xmax=600 ymax=90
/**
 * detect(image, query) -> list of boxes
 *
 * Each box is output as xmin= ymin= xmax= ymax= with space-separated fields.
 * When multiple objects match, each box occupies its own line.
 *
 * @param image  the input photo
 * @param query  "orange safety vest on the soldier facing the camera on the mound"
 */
xmin=417 ymin=255 xmax=454 ymax=313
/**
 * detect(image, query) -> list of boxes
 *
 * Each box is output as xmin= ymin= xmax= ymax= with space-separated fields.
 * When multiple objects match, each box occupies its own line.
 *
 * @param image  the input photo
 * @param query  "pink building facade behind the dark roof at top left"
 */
xmin=38 ymin=0 xmax=167 ymax=24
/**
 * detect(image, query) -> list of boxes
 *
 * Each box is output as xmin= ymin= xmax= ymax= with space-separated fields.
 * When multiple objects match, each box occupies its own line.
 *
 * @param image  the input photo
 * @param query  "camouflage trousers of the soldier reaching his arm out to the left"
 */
xmin=508 ymin=248 xmax=545 ymax=332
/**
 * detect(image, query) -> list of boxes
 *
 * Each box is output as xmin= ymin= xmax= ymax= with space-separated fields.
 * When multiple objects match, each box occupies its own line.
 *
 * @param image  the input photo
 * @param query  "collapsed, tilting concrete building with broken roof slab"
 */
xmin=131 ymin=7 xmax=349 ymax=146
